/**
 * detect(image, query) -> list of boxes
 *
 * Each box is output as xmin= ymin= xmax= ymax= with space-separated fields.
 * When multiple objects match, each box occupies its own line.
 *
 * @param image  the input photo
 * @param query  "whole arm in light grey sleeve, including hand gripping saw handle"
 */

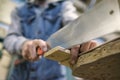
xmin=4 ymin=8 xmax=47 ymax=61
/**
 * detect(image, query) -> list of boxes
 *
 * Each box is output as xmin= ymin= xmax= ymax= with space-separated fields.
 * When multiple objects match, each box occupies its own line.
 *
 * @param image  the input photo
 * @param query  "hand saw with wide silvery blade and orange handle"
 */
xmin=38 ymin=0 xmax=120 ymax=55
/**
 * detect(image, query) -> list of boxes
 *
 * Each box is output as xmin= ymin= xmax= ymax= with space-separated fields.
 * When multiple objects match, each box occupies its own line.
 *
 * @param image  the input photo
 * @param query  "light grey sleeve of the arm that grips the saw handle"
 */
xmin=4 ymin=10 xmax=27 ymax=54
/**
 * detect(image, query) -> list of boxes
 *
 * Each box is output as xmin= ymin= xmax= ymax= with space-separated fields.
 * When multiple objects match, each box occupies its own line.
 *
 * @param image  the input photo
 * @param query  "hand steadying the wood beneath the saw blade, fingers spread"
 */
xmin=70 ymin=40 xmax=98 ymax=65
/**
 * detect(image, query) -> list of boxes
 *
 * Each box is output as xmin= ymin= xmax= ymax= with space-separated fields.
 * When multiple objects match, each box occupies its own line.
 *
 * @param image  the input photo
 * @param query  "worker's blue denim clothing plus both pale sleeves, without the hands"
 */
xmin=4 ymin=1 xmax=78 ymax=80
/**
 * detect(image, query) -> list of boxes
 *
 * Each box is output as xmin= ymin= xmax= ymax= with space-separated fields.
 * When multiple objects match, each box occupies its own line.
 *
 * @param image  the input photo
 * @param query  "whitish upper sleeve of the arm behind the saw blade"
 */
xmin=61 ymin=1 xmax=80 ymax=25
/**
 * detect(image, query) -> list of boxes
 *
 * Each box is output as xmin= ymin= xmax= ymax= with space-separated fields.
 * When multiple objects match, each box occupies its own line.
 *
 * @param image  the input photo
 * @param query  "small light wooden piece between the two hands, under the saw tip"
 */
xmin=44 ymin=46 xmax=70 ymax=67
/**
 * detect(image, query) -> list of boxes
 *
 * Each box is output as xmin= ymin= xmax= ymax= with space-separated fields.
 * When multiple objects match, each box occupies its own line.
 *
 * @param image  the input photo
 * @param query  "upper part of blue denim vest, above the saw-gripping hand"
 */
xmin=17 ymin=3 xmax=62 ymax=40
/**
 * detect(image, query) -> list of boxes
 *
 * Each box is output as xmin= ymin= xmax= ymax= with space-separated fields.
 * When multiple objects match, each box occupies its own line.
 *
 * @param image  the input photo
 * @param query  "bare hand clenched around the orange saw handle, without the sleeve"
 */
xmin=22 ymin=39 xmax=47 ymax=61
